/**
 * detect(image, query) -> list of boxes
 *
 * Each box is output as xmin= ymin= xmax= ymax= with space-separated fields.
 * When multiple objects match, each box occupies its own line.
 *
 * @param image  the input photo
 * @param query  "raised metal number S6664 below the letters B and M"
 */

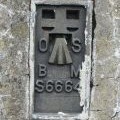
xmin=35 ymin=80 xmax=79 ymax=93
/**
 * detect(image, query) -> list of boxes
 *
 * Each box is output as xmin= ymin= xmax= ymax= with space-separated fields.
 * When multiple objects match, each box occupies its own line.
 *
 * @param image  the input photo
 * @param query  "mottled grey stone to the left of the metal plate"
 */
xmin=0 ymin=0 xmax=30 ymax=120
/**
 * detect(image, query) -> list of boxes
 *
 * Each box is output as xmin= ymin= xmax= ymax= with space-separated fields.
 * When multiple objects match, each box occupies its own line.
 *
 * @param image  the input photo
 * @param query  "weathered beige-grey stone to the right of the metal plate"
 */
xmin=90 ymin=0 xmax=120 ymax=120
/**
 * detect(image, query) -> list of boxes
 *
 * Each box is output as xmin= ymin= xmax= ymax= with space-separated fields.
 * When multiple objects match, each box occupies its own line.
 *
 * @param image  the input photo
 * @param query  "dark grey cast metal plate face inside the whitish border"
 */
xmin=34 ymin=5 xmax=86 ymax=113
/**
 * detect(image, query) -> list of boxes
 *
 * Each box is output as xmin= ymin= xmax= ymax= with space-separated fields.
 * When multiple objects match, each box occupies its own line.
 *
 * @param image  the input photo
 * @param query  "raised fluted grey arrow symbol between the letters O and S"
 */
xmin=49 ymin=38 xmax=72 ymax=65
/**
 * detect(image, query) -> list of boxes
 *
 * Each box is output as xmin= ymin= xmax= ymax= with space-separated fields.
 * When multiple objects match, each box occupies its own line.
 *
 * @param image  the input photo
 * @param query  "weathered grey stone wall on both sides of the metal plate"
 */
xmin=0 ymin=0 xmax=120 ymax=120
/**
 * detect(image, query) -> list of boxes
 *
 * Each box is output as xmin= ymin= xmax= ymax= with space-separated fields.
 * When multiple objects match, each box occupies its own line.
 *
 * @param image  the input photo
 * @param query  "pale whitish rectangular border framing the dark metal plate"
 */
xmin=28 ymin=0 xmax=93 ymax=120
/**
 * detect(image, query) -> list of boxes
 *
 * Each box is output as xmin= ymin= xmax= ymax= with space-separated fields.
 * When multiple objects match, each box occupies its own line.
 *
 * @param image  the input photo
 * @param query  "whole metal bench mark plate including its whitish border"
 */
xmin=29 ymin=0 xmax=93 ymax=120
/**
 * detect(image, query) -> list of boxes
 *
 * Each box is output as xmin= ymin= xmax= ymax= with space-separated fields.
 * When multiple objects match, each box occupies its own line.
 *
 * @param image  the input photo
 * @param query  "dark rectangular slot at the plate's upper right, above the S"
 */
xmin=66 ymin=10 xmax=79 ymax=19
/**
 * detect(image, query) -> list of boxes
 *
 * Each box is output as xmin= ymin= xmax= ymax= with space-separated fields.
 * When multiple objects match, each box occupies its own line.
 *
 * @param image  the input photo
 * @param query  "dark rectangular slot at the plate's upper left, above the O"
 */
xmin=42 ymin=9 xmax=55 ymax=19
